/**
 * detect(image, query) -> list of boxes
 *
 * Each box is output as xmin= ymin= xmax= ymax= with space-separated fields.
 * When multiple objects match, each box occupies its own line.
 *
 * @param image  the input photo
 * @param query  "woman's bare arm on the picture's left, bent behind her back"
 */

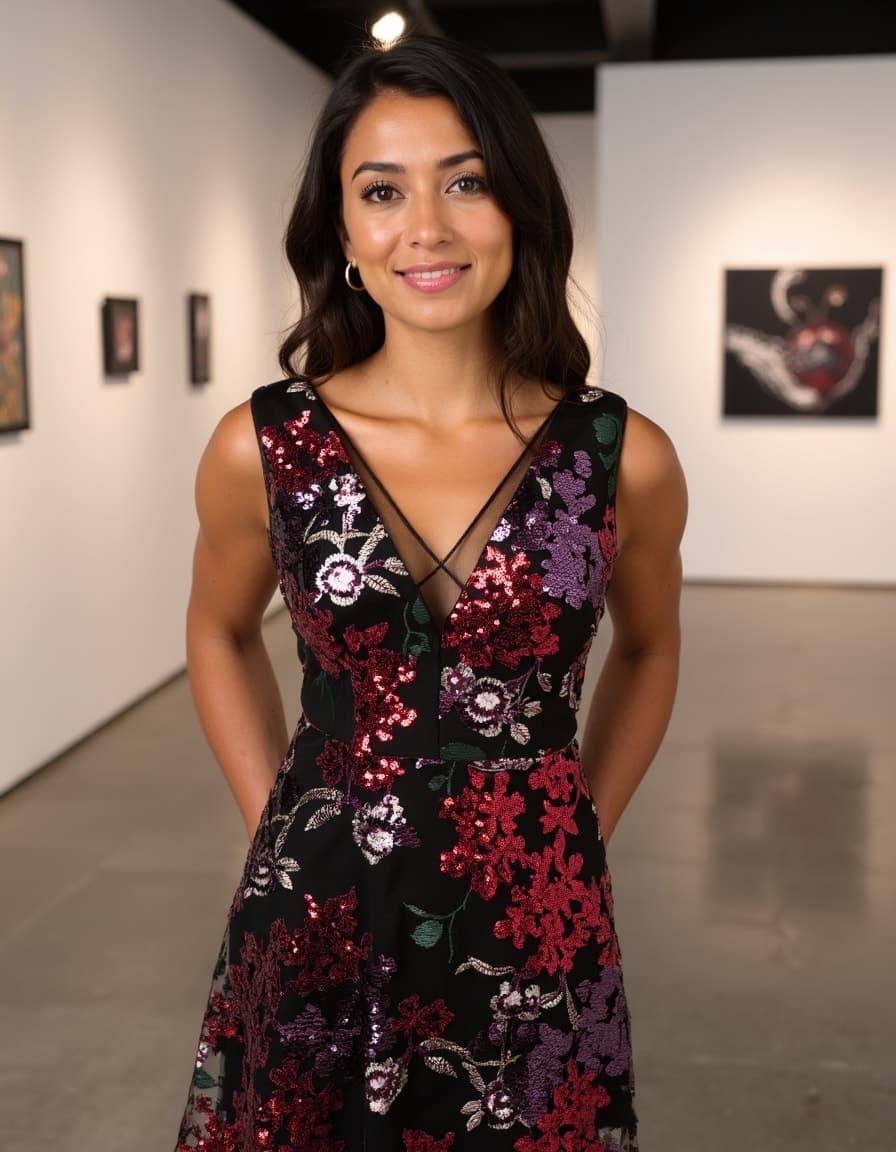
xmin=187 ymin=402 xmax=289 ymax=838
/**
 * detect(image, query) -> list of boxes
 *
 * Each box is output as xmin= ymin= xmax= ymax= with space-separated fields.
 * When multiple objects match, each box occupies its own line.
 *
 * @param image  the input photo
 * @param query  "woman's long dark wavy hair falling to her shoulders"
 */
xmin=280 ymin=36 xmax=591 ymax=418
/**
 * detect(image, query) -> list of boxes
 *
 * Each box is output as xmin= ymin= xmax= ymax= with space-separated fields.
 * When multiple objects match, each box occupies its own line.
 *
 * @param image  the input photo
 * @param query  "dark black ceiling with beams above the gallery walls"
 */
xmin=226 ymin=0 xmax=896 ymax=112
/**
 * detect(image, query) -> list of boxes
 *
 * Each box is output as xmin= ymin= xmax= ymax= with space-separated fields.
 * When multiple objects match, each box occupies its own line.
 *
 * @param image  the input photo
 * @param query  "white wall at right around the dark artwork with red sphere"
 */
xmin=598 ymin=56 xmax=896 ymax=584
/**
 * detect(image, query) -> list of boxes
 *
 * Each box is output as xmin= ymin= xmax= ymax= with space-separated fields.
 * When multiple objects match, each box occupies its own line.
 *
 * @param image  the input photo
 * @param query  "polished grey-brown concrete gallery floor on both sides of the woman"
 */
xmin=0 ymin=586 xmax=896 ymax=1152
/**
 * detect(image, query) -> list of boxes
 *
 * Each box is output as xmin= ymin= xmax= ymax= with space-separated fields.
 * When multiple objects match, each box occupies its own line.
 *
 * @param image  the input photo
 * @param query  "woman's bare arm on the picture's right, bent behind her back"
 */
xmin=582 ymin=411 xmax=688 ymax=841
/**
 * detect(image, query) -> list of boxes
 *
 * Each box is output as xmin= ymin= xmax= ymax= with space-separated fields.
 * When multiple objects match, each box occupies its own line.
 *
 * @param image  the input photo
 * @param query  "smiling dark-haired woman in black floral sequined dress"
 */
xmin=179 ymin=31 xmax=685 ymax=1152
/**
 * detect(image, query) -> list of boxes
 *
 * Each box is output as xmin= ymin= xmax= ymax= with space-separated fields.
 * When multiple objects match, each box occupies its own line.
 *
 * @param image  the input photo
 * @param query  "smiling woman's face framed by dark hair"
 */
xmin=340 ymin=92 xmax=514 ymax=334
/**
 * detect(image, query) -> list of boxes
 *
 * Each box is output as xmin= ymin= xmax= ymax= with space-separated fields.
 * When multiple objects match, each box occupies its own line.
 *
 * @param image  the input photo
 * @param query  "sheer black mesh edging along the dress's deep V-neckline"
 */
xmin=296 ymin=377 xmax=567 ymax=645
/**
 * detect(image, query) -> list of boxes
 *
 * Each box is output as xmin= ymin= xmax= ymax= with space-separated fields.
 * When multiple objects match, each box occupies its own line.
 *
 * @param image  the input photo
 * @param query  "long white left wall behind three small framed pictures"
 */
xmin=0 ymin=0 xmax=328 ymax=791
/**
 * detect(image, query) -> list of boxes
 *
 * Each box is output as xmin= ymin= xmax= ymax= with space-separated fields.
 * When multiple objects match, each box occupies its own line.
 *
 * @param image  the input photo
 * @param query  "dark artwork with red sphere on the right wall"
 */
xmin=723 ymin=266 xmax=883 ymax=419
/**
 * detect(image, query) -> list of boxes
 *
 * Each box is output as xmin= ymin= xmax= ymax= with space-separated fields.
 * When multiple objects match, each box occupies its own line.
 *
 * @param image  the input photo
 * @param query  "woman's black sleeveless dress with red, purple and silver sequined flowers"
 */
xmin=177 ymin=379 xmax=637 ymax=1152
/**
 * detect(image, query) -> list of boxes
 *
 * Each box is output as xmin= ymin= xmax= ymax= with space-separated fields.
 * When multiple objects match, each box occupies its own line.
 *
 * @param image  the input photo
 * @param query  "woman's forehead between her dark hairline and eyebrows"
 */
xmin=342 ymin=92 xmax=478 ymax=172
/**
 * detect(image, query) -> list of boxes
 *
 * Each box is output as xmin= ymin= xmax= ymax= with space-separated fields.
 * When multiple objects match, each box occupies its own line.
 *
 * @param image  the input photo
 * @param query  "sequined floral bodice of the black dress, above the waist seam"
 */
xmin=257 ymin=381 xmax=622 ymax=759
